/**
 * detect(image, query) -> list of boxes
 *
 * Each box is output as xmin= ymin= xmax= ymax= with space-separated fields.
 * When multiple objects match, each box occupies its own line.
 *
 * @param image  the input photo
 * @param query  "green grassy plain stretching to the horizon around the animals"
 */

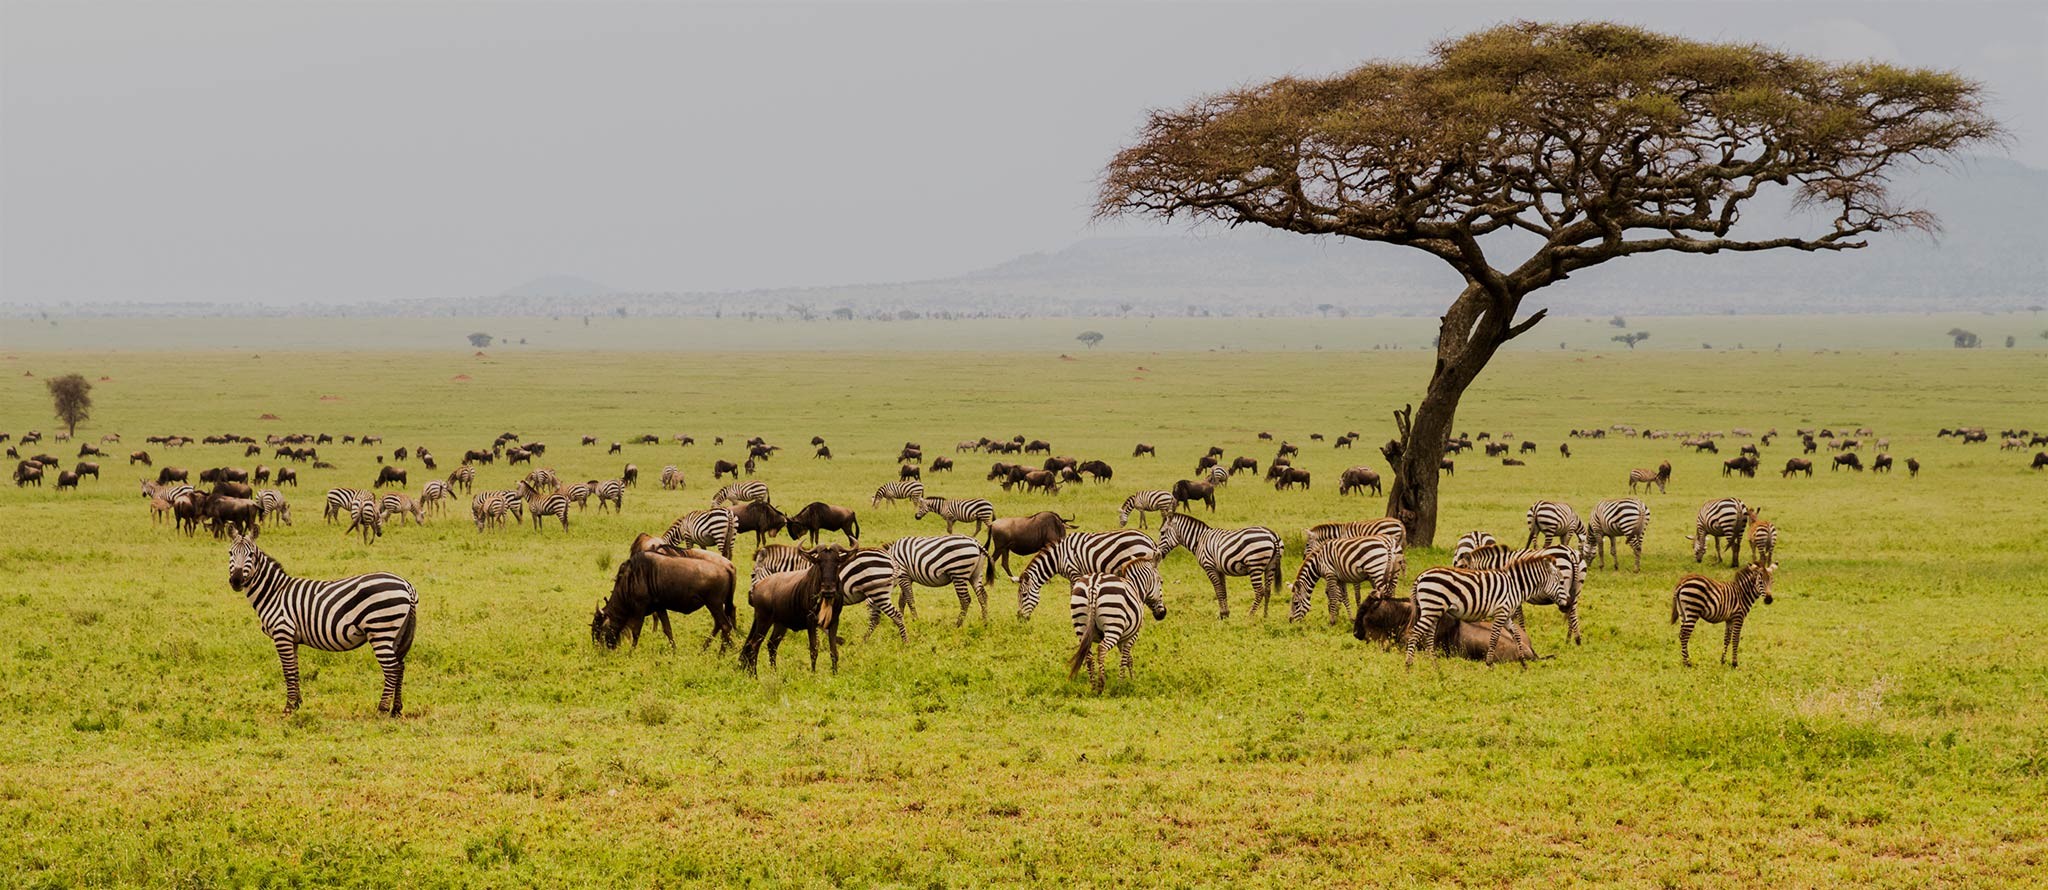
xmin=0 ymin=319 xmax=2048 ymax=888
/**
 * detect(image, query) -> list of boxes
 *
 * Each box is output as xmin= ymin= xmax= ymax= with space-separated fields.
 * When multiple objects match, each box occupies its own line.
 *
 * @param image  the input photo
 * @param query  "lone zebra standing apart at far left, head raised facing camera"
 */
xmin=227 ymin=534 xmax=420 ymax=716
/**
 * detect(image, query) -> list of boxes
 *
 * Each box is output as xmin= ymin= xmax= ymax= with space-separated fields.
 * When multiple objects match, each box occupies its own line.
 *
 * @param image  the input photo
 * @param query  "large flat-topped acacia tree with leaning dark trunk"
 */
xmin=1096 ymin=23 xmax=2003 ymax=546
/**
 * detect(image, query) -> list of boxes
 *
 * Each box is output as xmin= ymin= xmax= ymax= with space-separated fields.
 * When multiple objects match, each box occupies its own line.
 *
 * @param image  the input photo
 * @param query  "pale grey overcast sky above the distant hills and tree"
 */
xmin=0 ymin=0 xmax=2048 ymax=303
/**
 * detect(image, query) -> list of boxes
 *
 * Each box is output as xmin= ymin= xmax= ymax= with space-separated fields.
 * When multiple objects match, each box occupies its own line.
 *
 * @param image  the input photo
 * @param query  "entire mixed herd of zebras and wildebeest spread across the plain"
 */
xmin=0 ymin=426 xmax=2048 ymax=714
